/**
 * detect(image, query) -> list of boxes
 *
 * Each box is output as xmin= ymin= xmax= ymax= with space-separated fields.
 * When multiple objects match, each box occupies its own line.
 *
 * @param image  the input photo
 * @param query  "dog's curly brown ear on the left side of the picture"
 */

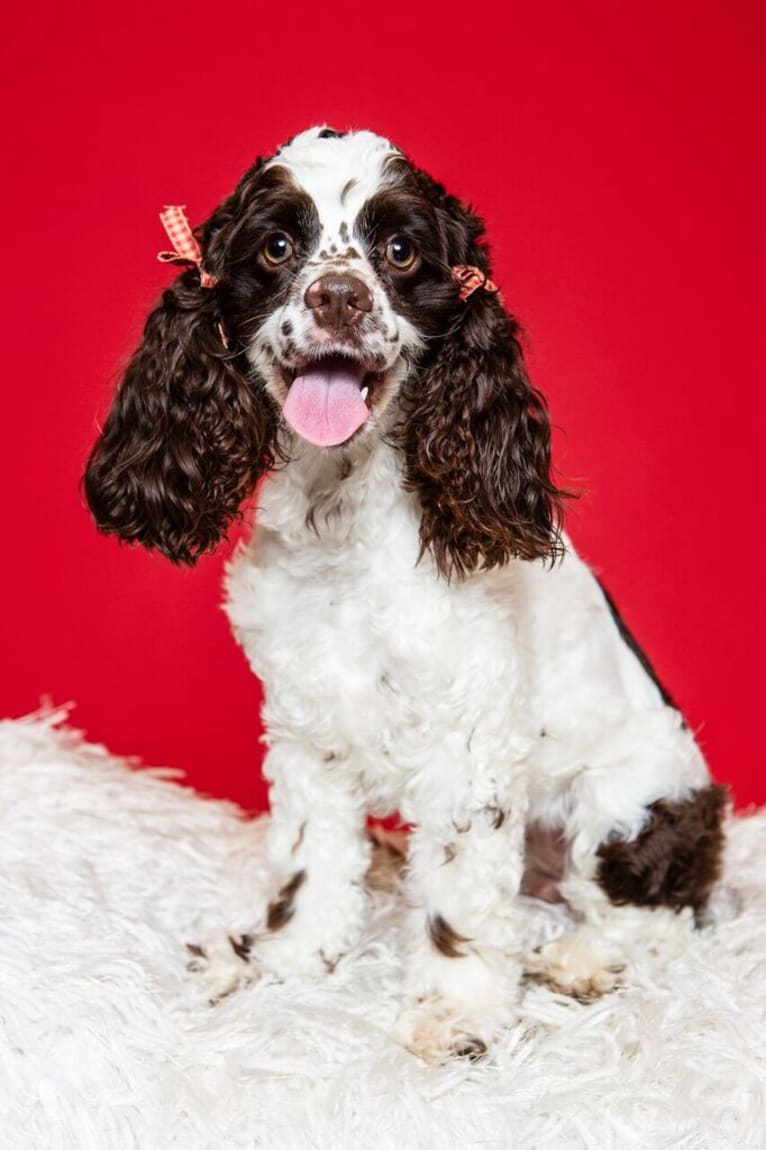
xmin=84 ymin=271 xmax=276 ymax=565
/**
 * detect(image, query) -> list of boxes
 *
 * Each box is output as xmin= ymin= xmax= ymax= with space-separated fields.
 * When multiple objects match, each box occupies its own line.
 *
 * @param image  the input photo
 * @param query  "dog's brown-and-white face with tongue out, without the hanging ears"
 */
xmin=208 ymin=129 xmax=468 ymax=447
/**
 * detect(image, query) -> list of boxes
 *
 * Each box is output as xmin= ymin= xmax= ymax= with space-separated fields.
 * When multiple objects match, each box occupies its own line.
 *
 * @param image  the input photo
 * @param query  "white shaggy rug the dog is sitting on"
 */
xmin=0 ymin=712 xmax=766 ymax=1150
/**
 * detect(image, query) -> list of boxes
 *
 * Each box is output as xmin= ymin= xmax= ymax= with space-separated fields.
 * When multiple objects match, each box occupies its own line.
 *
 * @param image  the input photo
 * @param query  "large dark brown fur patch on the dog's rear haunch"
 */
xmin=597 ymin=784 xmax=727 ymax=912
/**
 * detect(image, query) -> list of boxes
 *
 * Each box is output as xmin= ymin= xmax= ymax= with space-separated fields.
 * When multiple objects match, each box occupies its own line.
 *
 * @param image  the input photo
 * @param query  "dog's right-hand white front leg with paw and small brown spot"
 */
xmin=397 ymin=785 xmax=526 ymax=1061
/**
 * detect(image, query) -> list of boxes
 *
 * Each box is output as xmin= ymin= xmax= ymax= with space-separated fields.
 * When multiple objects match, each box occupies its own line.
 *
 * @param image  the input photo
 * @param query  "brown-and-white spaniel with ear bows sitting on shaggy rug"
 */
xmin=84 ymin=128 xmax=727 ymax=1061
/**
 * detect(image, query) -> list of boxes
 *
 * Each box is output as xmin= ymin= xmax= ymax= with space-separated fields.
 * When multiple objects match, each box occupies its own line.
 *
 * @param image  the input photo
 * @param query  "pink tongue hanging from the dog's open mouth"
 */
xmin=282 ymin=359 xmax=369 ymax=447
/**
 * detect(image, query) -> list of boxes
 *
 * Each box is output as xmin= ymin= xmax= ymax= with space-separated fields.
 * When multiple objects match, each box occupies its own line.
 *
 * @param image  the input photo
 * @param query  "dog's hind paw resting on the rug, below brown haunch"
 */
xmin=524 ymin=930 xmax=626 ymax=1003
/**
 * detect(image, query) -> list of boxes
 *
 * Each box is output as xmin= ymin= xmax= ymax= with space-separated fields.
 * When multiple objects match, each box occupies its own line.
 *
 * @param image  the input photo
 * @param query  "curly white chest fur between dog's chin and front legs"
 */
xmin=227 ymin=447 xmax=519 ymax=813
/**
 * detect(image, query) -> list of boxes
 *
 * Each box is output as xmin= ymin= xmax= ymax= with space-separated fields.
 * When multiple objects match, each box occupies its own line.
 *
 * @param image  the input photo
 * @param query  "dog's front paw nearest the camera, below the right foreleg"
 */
xmin=393 ymin=995 xmax=500 ymax=1065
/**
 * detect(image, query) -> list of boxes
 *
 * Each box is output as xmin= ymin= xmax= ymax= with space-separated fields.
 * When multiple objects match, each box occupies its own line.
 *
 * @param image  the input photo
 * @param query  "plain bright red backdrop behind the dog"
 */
xmin=0 ymin=0 xmax=766 ymax=806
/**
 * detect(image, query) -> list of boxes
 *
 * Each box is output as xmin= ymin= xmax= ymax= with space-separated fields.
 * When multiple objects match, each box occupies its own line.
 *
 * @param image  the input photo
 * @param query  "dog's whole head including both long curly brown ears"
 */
xmin=85 ymin=129 xmax=560 ymax=576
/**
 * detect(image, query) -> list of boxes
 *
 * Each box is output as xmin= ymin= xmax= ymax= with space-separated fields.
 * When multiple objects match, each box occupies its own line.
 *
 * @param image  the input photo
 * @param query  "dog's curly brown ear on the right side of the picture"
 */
xmin=400 ymin=286 xmax=566 ymax=578
